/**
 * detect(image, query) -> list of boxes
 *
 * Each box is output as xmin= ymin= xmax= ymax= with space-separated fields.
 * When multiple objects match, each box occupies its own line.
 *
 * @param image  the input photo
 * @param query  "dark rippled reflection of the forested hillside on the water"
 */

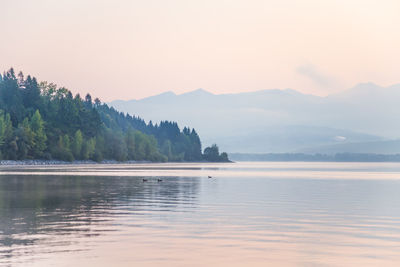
xmin=0 ymin=175 xmax=198 ymax=262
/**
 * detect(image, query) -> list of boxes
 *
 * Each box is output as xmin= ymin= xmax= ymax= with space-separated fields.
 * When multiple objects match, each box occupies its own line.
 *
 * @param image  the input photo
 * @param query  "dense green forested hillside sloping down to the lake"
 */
xmin=0 ymin=69 xmax=227 ymax=162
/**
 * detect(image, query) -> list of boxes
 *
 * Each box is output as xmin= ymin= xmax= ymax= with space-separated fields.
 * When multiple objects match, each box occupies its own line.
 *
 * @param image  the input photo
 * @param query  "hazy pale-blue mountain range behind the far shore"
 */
xmin=110 ymin=83 xmax=400 ymax=153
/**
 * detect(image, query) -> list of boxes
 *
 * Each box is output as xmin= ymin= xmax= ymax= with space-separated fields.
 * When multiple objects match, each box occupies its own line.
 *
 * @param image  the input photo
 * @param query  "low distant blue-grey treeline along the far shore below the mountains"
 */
xmin=230 ymin=153 xmax=400 ymax=162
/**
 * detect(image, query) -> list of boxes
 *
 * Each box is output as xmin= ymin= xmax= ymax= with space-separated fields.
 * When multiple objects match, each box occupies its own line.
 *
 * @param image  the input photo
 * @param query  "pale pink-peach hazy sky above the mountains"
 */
xmin=0 ymin=0 xmax=400 ymax=101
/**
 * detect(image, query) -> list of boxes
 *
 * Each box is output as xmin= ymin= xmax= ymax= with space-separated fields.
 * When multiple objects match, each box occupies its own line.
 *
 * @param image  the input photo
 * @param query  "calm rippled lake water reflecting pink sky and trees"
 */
xmin=0 ymin=162 xmax=400 ymax=267
